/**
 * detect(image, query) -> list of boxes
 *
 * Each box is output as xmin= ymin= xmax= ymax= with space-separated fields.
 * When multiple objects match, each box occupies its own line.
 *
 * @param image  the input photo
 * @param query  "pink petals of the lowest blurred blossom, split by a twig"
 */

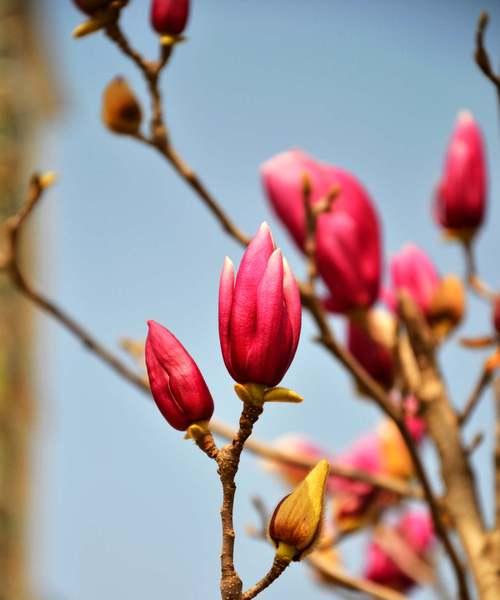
xmin=364 ymin=511 xmax=434 ymax=592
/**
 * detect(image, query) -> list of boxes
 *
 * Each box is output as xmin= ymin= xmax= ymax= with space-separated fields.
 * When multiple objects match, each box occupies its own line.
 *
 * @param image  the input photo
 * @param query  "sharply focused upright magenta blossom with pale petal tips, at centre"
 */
xmin=219 ymin=223 xmax=302 ymax=387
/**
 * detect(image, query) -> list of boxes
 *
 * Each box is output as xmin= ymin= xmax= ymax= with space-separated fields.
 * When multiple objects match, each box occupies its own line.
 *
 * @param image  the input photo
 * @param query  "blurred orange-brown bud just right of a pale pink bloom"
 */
xmin=427 ymin=275 xmax=465 ymax=340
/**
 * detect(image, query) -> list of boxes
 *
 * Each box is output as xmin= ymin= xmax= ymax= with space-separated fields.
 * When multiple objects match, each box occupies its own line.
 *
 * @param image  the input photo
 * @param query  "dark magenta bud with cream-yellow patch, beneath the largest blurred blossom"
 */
xmin=347 ymin=310 xmax=396 ymax=389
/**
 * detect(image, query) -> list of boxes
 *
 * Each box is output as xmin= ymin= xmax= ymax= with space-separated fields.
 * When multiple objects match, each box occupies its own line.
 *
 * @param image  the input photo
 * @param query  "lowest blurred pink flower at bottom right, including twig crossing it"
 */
xmin=364 ymin=511 xmax=434 ymax=592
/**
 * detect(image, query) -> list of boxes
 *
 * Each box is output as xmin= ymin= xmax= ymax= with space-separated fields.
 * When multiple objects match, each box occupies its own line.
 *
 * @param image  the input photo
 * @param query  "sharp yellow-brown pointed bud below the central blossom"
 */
xmin=269 ymin=459 xmax=329 ymax=560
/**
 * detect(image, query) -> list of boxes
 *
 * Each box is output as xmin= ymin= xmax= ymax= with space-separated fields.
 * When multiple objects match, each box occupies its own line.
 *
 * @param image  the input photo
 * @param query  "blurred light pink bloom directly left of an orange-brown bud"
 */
xmin=384 ymin=244 xmax=441 ymax=314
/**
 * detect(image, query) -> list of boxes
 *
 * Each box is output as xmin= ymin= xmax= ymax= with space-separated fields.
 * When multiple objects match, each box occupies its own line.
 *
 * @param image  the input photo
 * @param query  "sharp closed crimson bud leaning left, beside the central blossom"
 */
xmin=146 ymin=321 xmax=214 ymax=431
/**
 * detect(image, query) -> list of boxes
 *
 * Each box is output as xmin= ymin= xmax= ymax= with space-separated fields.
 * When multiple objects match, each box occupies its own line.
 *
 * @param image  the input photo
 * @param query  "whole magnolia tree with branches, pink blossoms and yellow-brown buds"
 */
xmin=1 ymin=0 xmax=500 ymax=600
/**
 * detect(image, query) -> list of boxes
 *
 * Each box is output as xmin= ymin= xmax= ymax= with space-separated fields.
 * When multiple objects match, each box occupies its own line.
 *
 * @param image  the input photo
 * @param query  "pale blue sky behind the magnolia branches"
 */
xmin=2 ymin=0 xmax=500 ymax=600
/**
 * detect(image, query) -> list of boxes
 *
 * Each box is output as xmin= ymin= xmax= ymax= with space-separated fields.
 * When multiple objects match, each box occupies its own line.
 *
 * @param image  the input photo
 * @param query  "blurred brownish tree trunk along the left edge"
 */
xmin=0 ymin=0 xmax=55 ymax=600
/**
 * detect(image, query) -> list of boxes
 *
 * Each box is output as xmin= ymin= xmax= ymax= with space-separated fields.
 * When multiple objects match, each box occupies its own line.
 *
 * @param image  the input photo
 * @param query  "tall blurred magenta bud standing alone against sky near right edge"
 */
xmin=434 ymin=111 xmax=487 ymax=240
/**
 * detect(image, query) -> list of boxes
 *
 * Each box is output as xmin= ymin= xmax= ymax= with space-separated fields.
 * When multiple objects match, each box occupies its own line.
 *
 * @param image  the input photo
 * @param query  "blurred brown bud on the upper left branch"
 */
xmin=102 ymin=77 xmax=142 ymax=135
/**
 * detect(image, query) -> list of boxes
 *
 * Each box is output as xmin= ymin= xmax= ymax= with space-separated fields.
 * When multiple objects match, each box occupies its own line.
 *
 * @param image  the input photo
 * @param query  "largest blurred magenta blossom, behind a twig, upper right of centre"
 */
xmin=261 ymin=150 xmax=382 ymax=312
